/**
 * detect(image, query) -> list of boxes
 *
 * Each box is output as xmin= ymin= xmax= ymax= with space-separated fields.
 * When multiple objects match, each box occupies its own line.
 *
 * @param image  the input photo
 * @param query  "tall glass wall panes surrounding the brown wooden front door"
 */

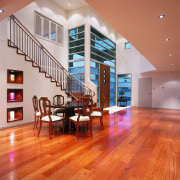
xmin=90 ymin=27 xmax=116 ymax=106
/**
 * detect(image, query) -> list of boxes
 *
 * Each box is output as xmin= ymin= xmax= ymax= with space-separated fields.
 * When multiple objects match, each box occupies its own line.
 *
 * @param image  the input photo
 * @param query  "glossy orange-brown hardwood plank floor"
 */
xmin=0 ymin=107 xmax=180 ymax=180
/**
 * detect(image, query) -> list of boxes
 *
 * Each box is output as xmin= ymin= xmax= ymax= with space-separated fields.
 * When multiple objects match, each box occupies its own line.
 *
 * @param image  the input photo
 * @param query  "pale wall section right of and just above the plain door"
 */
xmin=142 ymin=71 xmax=180 ymax=109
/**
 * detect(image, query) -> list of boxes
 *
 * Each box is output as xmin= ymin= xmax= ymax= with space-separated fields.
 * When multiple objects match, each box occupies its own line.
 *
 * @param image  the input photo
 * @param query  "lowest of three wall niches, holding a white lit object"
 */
xmin=7 ymin=107 xmax=23 ymax=122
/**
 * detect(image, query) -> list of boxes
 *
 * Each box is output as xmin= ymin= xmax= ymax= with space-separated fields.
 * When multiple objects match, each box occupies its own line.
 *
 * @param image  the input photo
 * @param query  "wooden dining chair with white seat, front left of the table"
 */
xmin=38 ymin=97 xmax=64 ymax=139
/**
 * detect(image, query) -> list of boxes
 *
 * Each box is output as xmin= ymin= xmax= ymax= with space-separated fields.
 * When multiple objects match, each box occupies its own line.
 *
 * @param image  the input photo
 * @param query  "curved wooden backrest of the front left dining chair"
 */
xmin=39 ymin=97 xmax=51 ymax=116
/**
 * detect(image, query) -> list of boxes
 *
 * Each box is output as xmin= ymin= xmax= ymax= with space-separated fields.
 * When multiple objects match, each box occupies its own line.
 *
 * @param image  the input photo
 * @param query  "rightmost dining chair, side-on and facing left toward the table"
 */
xmin=91 ymin=97 xmax=106 ymax=129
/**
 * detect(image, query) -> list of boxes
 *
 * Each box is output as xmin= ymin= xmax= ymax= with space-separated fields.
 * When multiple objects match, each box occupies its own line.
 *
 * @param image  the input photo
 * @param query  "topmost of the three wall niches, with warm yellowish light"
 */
xmin=7 ymin=69 xmax=23 ymax=84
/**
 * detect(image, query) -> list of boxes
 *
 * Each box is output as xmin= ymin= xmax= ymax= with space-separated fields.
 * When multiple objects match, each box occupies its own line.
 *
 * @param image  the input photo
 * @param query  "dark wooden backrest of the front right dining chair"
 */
xmin=78 ymin=95 xmax=93 ymax=117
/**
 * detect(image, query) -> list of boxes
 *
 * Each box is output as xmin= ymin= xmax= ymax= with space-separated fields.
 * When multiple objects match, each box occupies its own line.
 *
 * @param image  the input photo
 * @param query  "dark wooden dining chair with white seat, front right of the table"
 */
xmin=69 ymin=96 xmax=92 ymax=139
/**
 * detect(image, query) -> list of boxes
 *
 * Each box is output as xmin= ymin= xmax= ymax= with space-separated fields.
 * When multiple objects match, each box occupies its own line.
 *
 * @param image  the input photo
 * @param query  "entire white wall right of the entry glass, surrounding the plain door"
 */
xmin=116 ymin=34 xmax=180 ymax=109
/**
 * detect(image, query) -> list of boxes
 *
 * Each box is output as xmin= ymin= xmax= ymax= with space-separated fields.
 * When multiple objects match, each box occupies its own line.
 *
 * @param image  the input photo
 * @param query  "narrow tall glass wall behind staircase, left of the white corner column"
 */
xmin=68 ymin=26 xmax=85 ymax=82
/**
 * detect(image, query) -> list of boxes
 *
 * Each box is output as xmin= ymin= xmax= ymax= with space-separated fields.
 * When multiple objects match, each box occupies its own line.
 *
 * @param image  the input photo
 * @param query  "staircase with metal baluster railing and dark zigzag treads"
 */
xmin=8 ymin=15 xmax=95 ymax=100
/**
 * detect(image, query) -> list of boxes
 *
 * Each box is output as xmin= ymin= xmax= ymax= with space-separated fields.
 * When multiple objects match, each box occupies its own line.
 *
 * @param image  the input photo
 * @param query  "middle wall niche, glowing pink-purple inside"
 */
xmin=7 ymin=89 xmax=23 ymax=102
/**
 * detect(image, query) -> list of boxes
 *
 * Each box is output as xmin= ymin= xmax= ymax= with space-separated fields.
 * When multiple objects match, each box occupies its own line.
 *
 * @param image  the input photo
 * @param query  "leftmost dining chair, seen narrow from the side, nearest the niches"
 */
xmin=32 ymin=95 xmax=41 ymax=129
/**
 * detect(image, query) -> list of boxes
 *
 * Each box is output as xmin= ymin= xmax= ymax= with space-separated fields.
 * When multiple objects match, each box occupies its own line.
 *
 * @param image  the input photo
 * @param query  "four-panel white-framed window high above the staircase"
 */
xmin=35 ymin=12 xmax=63 ymax=44
